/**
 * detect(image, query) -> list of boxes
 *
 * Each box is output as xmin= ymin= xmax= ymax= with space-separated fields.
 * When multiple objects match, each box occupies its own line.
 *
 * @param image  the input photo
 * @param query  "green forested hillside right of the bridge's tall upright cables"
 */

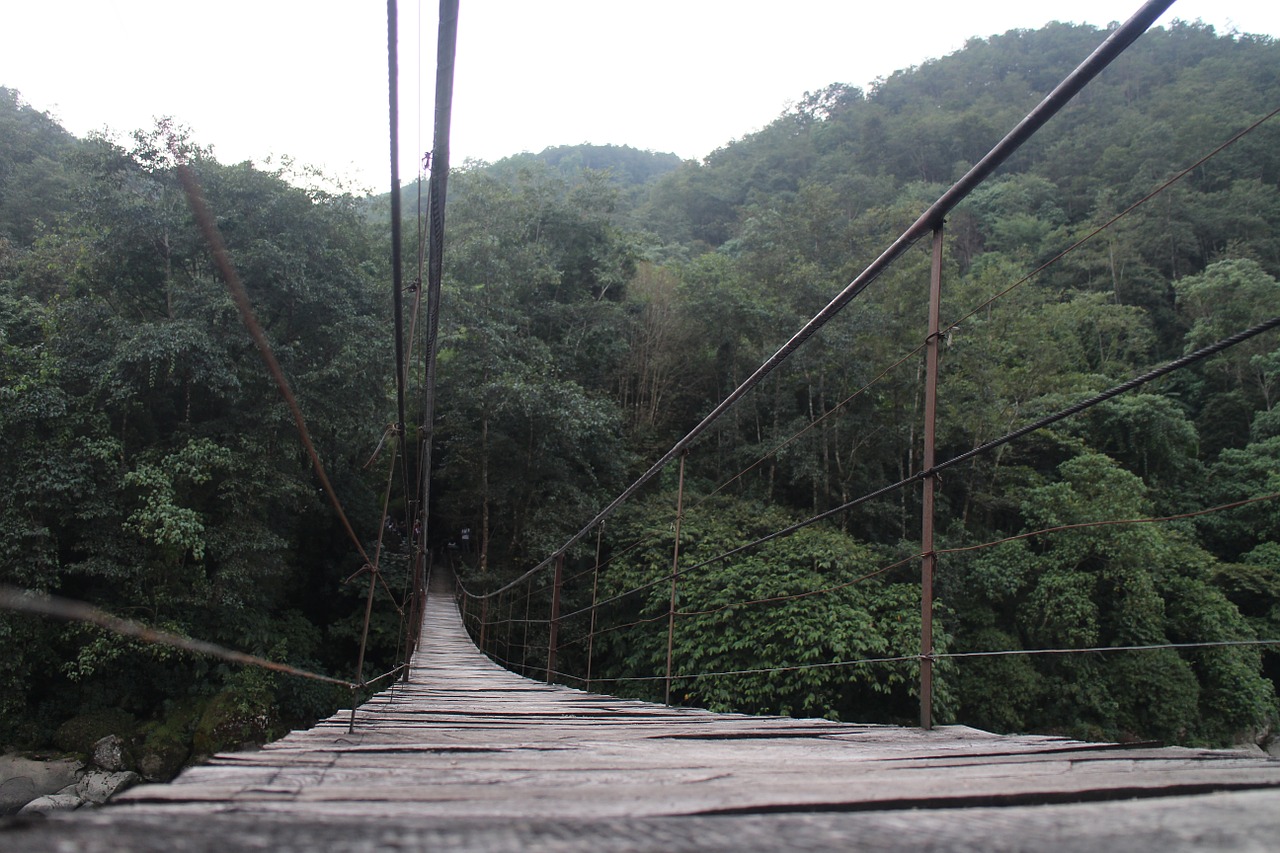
xmin=447 ymin=23 xmax=1280 ymax=743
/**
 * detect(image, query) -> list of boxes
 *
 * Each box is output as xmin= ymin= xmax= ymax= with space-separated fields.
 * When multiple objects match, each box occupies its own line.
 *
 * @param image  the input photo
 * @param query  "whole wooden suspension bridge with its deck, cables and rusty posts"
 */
xmin=0 ymin=1 xmax=1280 ymax=853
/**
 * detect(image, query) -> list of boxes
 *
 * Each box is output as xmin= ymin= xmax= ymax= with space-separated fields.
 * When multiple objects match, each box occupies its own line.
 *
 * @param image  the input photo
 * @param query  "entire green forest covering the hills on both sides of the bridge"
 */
xmin=0 ymin=22 xmax=1280 ymax=767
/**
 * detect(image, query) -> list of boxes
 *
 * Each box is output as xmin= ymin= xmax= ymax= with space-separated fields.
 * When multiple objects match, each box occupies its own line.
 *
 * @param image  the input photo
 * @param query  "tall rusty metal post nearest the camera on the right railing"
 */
xmin=920 ymin=224 xmax=943 ymax=729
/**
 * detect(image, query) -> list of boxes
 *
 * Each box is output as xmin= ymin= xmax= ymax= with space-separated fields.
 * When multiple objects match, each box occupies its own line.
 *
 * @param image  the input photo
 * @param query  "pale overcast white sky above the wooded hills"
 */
xmin=0 ymin=0 xmax=1280 ymax=190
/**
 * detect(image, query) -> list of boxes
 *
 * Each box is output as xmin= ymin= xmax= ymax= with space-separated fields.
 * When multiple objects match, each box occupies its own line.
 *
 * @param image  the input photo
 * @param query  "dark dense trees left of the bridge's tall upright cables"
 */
xmin=0 ymin=96 xmax=398 ymax=745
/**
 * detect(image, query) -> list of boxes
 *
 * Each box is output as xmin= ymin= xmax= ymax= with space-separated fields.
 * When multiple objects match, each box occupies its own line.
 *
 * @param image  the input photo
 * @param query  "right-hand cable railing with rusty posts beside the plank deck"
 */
xmin=458 ymin=3 xmax=1280 ymax=727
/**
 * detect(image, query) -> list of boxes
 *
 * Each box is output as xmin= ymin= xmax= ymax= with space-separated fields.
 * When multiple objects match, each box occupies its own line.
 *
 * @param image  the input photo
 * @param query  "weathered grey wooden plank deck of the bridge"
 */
xmin=0 ymin=568 xmax=1280 ymax=853
